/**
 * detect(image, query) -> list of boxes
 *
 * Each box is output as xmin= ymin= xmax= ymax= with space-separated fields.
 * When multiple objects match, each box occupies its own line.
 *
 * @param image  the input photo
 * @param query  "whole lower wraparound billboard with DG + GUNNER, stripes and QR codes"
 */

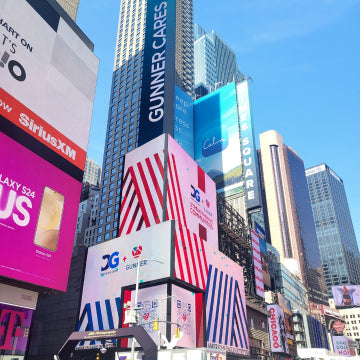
xmin=79 ymin=221 xmax=249 ymax=354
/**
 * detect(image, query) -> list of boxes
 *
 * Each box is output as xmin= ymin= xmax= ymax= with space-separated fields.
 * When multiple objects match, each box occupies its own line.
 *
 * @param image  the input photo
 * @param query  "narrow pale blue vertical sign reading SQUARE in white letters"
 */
xmin=236 ymin=81 xmax=261 ymax=209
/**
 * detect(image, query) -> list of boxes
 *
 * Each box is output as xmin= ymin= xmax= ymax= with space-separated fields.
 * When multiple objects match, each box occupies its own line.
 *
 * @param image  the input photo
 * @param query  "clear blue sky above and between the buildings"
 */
xmin=77 ymin=0 xmax=360 ymax=243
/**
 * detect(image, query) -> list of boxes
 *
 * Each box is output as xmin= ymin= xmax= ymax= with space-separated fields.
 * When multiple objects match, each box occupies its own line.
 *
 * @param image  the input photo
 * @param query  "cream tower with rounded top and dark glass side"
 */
xmin=260 ymin=130 xmax=327 ymax=304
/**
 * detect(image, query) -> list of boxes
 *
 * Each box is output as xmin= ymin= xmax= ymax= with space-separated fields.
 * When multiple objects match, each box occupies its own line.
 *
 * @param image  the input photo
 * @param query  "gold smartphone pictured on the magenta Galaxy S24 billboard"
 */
xmin=34 ymin=186 xmax=65 ymax=251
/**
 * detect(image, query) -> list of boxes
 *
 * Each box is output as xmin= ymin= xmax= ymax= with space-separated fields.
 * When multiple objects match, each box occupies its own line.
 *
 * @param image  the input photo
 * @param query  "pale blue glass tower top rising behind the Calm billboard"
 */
xmin=194 ymin=24 xmax=244 ymax=96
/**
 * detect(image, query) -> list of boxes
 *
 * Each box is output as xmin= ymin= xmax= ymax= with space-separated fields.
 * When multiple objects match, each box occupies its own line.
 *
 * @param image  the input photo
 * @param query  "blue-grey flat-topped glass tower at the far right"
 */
xmin=306 ymin=164 xmax=360 ymax=296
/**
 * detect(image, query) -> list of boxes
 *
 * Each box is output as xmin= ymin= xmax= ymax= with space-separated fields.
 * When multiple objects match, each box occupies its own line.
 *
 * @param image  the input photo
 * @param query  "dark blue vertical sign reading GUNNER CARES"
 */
xmin=138 ymin=0 xmax=176 ymax=145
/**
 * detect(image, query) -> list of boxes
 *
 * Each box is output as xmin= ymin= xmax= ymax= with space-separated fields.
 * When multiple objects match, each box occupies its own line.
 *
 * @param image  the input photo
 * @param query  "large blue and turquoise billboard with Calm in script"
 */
xmin=194 ymin=83 xmax=244 ymax=192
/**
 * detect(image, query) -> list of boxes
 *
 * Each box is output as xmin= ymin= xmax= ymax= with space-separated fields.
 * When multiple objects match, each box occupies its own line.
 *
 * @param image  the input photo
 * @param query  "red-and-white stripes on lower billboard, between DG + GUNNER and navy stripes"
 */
xmin=175 ymin=226 xmax=208 ymax=290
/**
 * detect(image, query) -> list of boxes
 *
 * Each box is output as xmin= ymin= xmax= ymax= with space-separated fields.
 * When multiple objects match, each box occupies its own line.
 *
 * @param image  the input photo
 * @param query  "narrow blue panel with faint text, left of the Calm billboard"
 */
xmin=174 ymin=86 xmax=194 ymax=158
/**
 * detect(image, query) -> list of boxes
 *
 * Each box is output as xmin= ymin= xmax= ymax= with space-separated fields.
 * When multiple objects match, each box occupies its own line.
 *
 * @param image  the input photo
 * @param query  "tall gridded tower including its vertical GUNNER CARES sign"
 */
xmin=97 ymin=0 xmax=193 ymax=242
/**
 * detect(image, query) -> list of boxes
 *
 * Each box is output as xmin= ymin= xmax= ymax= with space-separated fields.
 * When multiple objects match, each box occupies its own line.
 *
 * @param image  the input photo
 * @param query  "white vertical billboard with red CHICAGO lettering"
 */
xmin=267 ymin=304 xmax=289 ymax=354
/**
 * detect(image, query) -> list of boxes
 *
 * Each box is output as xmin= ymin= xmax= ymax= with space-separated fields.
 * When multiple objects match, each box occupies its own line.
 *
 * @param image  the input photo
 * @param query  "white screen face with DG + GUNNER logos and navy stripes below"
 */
xmin=79 ymin=221 xmax=172 ymax=330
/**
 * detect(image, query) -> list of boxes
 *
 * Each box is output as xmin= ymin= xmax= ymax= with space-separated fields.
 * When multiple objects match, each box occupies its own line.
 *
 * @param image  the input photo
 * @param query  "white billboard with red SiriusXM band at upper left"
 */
xmin=0 ymin=0 xmax=98 ymax=170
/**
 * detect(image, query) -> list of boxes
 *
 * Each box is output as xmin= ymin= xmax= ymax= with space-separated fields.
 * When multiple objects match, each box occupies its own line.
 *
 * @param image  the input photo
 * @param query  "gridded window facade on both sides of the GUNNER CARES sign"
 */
xmin=96 ymin=0 xmax=194 ymax=242
